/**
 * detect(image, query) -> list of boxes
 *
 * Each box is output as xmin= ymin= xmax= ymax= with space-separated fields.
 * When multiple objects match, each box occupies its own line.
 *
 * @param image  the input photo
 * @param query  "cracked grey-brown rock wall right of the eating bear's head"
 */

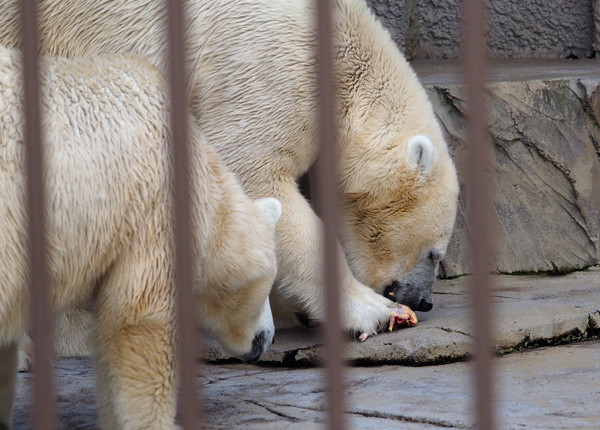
xmin=427 ymin=77 xmax=600 ymax=276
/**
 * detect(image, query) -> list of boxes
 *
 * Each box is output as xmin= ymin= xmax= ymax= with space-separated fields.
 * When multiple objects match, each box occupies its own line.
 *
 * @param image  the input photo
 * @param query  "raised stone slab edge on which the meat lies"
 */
xmin=205 ymin=266 xmax=600 ymax=366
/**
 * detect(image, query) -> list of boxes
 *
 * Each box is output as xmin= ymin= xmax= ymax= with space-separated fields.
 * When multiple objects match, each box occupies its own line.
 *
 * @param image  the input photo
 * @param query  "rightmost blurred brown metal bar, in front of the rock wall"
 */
xmin=464 ymin=0 xmax=495 ymax=430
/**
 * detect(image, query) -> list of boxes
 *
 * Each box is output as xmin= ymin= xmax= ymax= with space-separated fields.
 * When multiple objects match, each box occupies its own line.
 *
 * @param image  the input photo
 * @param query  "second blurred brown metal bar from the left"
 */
xmin=168 ymin=0 xmax=202 ymax=429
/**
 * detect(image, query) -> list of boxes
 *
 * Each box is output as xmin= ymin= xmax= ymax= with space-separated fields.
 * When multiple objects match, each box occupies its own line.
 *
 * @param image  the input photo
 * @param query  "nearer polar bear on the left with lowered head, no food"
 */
xmin=0 ymin=47 xmax=282 ymax=429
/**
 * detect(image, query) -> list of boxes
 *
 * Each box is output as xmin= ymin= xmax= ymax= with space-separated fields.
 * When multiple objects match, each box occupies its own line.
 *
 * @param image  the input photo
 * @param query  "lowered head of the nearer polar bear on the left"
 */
xmin=198 ymin=195 xmax=283 ymax=363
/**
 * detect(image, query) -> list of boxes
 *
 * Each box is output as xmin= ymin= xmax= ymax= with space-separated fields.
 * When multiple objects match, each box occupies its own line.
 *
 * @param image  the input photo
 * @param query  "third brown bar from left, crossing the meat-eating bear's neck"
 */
xmin=315 ymin=0 xmax=345 ymax=429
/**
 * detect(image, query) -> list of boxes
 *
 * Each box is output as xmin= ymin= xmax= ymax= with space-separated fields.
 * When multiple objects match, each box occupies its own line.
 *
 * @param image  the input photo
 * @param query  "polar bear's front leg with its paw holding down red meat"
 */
xmin=273 ymin=179 xmax=393 ymax=334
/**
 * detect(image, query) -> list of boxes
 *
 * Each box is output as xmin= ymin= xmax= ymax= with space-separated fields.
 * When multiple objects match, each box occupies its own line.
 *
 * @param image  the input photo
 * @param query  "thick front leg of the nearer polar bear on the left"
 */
xmin=93 ymin=230 xmax=177 ymax=430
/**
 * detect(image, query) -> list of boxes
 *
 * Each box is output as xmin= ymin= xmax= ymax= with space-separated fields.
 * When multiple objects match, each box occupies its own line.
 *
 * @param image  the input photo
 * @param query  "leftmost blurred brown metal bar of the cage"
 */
xmin=20 ymin=0 xmax=57 ymax=429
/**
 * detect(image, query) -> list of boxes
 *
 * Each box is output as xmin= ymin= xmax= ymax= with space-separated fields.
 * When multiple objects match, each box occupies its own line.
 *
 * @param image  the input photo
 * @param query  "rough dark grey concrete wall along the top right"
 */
xmin=367 ymin=0 xmax=600 ymax=59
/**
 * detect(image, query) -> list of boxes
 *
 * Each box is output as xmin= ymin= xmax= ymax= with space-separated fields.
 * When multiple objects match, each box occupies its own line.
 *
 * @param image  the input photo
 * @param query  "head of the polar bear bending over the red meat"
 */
xmin=341 ymin=133 xmax=459 ymax=311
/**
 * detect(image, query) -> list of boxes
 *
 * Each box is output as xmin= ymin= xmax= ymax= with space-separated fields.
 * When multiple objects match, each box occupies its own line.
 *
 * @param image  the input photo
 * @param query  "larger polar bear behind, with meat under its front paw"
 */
xmin=0 ymin=0 xmax=458 ymax=340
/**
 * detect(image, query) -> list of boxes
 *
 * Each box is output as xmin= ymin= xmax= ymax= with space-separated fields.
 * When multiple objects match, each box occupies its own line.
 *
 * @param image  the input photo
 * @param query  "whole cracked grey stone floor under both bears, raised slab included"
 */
xmin=14 ymin=267 xmax=600 ymax=430
